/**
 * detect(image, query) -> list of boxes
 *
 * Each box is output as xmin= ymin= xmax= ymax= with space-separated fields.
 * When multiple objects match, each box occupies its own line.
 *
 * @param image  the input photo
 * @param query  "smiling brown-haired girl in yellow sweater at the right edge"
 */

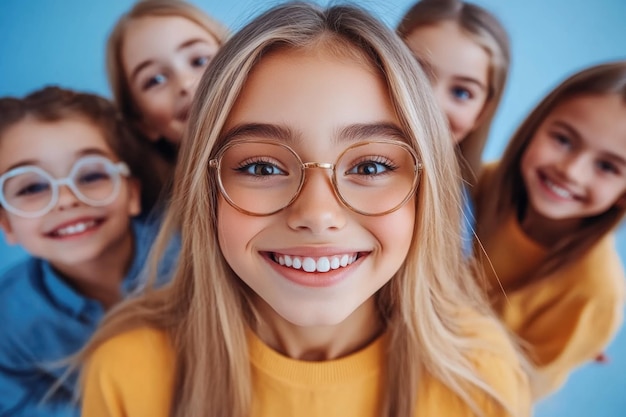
xmin=476 ymin=61 xmax=626 ymax=397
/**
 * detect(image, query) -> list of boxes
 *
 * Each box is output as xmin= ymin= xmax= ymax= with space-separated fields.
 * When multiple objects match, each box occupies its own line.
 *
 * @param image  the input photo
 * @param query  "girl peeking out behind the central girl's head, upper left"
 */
xmin=106 ymin=0 xmax=227 ymax=183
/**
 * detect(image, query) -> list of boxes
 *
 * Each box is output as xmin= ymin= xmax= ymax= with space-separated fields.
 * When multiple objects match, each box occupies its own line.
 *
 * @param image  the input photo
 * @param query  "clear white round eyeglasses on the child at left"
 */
xmin=0 ymin=155 xmax=130 ymax=218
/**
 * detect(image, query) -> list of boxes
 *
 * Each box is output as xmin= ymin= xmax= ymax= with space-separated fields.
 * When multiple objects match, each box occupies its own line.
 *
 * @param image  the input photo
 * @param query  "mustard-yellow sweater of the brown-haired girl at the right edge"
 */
xmin=478 ymin=162 xmax=625 ymax=398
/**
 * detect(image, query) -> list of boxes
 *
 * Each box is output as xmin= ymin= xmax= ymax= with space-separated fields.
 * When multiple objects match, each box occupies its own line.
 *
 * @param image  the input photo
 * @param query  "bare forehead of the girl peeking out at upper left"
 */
xmin=121 ymin=16 xmax=218 ymax=70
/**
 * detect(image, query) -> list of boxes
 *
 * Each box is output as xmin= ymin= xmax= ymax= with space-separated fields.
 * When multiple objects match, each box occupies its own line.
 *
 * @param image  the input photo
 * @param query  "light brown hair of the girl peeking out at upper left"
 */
xmin=106 ymin=0 xmax=228 ymax=133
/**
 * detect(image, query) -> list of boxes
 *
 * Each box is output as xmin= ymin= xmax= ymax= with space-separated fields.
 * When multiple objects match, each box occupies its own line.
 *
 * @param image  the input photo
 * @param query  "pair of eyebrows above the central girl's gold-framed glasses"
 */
xmin=222 ymin=122 xmax=406 ymax=144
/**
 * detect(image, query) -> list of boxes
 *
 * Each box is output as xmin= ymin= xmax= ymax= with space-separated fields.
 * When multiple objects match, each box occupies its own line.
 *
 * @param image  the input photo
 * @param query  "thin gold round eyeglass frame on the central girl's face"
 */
xmin=209 ymin=139 xmax=423 ymax=217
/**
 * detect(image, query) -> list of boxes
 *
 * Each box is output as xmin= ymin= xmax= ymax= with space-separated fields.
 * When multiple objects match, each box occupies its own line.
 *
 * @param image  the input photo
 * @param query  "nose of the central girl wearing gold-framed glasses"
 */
xmin=286 ymin=168 xmax=347 ymax=235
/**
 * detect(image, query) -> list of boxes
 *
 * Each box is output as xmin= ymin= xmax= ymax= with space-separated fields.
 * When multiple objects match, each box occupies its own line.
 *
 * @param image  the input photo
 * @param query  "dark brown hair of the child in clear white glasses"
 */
xmin=0 ymin=86 xmax=161 ymax=211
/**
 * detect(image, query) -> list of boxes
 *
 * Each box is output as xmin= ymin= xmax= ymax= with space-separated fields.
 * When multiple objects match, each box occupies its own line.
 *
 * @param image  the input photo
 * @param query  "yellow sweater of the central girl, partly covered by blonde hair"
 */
xmin=82 ymin=328 xmax=530 ymax=417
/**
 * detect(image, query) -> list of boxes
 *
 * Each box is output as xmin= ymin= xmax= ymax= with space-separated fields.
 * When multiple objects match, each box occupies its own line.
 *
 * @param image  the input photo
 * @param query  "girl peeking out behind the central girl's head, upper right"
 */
xmin=397 ymin=0 xmax=511 ymax=185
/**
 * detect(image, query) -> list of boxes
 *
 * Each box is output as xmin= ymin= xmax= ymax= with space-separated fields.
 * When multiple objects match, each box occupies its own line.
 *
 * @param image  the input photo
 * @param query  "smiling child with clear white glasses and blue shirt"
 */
xmin=0 ymin=87 xmax=174 ymax=417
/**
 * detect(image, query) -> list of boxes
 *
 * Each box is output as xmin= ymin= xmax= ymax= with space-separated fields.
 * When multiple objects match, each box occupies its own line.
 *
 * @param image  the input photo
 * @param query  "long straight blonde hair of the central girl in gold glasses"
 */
xmin=79 ymin=3 xmax=520 ymax=417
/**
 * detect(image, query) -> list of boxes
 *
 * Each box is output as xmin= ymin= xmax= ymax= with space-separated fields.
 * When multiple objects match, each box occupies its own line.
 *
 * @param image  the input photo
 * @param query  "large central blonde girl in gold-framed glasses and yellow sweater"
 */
xmin=80 ymin=3 xmax=529 ymax=417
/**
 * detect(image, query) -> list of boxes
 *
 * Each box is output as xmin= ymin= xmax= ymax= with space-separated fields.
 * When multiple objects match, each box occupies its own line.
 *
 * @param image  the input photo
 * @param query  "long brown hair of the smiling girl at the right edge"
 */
xmin=476 ymin=61 xmax=626 ymax=279
